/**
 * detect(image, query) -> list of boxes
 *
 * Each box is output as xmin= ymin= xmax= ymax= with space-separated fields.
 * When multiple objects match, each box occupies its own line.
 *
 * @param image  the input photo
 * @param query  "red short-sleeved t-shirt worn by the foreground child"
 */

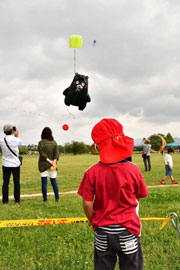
xmin=78 ymin=162 xmax=148 ymax=236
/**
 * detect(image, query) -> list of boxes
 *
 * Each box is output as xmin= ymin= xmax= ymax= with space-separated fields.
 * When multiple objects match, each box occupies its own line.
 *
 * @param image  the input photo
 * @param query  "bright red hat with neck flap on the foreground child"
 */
xmin=91 ymin=119 xmax=134 ymax=163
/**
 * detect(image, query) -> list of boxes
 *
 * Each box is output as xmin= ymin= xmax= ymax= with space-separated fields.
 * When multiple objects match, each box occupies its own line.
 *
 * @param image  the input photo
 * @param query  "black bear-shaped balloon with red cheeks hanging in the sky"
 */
xmin=63 ymin=73 xmax=91 ymax=111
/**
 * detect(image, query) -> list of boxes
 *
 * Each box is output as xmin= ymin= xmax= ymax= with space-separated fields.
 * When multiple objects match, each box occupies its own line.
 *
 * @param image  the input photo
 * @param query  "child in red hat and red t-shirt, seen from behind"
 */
xmin=78 ymin=119 xmax=148 ymax=270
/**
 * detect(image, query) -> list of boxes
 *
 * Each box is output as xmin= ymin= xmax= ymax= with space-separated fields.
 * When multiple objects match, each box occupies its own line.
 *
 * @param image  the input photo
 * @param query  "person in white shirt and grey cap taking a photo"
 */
xmin=0 ymin=124 xmax=23 ymax=205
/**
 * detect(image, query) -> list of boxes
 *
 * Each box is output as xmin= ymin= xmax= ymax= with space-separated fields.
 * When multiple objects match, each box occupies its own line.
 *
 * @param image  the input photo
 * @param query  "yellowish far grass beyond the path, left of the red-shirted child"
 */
xmin=0 ymin=155 xmax=98 ymax=195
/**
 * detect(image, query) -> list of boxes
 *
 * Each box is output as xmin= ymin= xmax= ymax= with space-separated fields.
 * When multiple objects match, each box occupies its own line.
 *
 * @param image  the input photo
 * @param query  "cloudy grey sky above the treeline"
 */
xmin=0 ymin=0 xmax=180 ymax=144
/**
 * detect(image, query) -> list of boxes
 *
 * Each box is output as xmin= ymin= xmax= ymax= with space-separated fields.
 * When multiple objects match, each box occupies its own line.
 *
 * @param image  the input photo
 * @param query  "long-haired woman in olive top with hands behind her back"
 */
xmin=38 ymin=127 xmax=59 ymax=202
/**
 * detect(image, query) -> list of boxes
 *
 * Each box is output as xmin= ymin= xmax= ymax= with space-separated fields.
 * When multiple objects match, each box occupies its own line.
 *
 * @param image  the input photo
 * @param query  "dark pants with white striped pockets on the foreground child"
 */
xmin=94 ymin=226 xmax=143 ymax=270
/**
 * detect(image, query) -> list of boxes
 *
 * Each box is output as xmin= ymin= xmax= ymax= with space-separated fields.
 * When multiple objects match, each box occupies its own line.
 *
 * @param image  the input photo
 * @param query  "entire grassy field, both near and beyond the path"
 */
xmin=0 ymin=154 xmax=180 ymax=270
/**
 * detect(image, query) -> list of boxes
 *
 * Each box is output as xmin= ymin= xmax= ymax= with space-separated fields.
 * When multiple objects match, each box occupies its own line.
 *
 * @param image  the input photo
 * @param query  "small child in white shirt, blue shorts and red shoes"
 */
xmin=160 ymin=148 xmax=178 ymax=184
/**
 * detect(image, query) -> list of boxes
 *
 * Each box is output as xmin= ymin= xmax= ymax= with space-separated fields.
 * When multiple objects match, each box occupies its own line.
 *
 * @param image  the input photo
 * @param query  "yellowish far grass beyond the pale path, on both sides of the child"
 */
xmin=0 ymin=153 xmax=180 ymax=195
